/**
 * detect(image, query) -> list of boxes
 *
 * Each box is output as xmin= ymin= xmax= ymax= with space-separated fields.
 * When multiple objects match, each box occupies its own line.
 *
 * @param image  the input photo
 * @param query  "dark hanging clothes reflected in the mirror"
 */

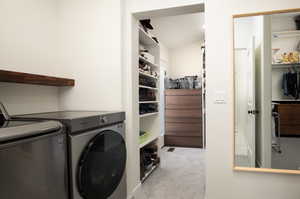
xmin=282 ymin=72 xmax=299 ymax=99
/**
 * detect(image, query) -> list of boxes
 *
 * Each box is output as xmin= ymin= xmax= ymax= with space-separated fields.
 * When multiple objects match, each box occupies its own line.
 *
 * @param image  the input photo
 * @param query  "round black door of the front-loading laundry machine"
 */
xmin=77 ymin=130 xmax=126 ymax=199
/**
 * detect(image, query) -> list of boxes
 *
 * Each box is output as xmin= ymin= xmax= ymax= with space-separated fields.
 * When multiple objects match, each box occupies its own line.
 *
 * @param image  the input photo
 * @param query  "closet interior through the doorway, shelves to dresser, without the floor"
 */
xmin=137 ymin=13 xmax=205 ymax=182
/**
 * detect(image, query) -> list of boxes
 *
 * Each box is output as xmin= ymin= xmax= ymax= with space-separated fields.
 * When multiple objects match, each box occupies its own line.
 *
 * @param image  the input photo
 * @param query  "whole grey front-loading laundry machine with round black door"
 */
xmin=15 ymin=111 xmax=127 ymax=199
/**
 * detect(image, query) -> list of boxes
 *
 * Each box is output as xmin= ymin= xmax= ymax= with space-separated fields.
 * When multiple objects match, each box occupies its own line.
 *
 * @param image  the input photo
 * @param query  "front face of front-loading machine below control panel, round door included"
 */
xmin=70 ymin=123 xmax=127 ymax=199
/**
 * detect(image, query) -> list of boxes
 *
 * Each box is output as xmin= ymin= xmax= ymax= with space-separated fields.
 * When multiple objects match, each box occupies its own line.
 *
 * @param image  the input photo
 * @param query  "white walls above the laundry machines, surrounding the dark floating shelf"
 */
xmin=0 ymin=0 xmax=122 ymax=113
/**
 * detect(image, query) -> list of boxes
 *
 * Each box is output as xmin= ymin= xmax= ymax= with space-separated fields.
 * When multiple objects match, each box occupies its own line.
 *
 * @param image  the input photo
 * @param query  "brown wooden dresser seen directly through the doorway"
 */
xmin=165 ymin=89 xmax=203 ymax=148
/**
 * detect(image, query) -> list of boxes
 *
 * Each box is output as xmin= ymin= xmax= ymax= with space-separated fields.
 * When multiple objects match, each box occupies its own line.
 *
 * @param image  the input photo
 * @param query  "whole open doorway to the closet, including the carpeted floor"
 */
xmin=124 ymin=4 xmax=205 ymax=199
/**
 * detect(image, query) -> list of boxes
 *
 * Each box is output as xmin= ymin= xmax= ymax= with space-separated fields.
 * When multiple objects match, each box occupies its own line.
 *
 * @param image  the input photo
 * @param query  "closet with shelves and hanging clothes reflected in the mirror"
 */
xmin=271 ymin=13 xmax=300 ymax=169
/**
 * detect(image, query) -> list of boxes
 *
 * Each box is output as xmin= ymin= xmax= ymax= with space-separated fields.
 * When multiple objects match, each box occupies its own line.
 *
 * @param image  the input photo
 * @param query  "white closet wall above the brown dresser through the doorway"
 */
xmin=170 ymin=42 xmax=203 ymax=78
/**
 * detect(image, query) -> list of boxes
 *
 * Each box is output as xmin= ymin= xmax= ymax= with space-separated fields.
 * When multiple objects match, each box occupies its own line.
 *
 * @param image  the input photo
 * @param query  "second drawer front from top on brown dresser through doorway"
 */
xmin=166 ymin=96 xmax=201 ymax=109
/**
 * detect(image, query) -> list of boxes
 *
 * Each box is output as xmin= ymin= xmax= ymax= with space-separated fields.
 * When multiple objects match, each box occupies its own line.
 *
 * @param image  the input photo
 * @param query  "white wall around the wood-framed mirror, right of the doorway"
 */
xmin=205 ymin=0 xmax=300 ymax=199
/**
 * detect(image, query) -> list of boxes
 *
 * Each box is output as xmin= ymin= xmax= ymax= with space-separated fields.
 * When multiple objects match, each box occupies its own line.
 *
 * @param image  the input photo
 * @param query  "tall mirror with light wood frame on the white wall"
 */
xmin=233 ymin=9 xmax=300 ymax=174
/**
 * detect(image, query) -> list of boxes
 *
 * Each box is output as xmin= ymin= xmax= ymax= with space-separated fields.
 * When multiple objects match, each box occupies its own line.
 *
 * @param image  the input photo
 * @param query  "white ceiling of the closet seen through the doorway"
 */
xmin=151 ymin=13 xmax=204 ymax=49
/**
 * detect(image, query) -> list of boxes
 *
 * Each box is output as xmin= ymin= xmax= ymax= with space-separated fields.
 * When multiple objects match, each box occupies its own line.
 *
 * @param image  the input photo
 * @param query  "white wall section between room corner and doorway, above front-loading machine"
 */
xmin=59 ymin=0 xmax=122 ymax=110
